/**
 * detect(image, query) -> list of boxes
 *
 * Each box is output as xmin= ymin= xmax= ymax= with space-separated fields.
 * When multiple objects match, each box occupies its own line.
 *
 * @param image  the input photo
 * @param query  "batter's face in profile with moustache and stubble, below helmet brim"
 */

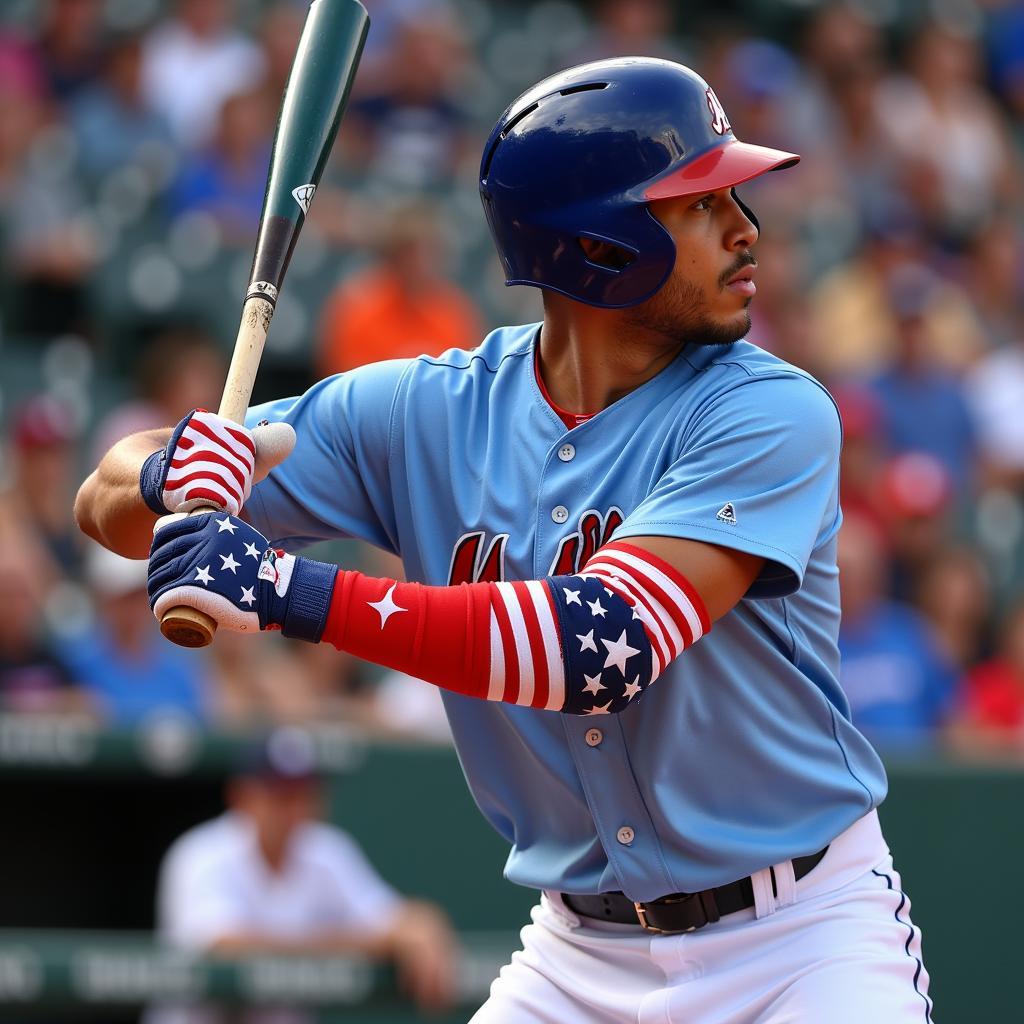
xmin=626 ymin=188 xmax=758 ymax=345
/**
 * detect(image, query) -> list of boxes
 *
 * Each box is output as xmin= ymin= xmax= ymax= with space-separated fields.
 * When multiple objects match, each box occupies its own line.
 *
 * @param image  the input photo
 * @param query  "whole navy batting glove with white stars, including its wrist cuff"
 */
xmin=148 ymin=512 xmax=338 ymax=642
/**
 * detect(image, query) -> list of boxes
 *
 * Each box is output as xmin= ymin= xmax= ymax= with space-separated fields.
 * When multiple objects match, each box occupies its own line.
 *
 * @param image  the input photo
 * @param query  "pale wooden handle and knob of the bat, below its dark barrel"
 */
xmin=160 ymin=296 xmax=273 ymax=647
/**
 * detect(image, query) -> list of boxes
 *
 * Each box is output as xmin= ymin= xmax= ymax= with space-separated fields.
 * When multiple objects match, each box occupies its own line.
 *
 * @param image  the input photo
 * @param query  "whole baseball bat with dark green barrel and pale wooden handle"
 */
xmin=160 ymin=0 xmax=370 ymax=647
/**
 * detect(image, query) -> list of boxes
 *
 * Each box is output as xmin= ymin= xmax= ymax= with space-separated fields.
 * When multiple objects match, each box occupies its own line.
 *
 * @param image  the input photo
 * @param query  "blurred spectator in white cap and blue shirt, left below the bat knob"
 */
xmin=57 ymin=544 xmax=211 ymax=726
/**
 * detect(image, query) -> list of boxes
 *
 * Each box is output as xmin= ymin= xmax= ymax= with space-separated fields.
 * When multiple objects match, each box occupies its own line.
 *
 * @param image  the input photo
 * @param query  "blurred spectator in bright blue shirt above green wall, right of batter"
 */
xmin=839 ymin=516 xmax=956 ymax=749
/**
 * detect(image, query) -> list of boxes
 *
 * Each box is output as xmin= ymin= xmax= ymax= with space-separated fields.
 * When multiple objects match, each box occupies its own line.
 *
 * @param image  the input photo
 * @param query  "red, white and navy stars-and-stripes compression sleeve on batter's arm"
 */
xmin=319 ymin=543 xmax=711 ymax=715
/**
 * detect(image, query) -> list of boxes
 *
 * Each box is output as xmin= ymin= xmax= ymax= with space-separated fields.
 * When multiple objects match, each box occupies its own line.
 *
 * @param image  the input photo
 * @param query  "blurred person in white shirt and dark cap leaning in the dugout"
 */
xmin=145 ymin=727 xmax=455 ymax=1024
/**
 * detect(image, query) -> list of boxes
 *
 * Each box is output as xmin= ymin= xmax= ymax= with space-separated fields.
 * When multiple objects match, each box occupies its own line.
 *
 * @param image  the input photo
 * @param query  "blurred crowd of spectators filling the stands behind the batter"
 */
xmin=0 ymin=0 xmax=1024 ymax=757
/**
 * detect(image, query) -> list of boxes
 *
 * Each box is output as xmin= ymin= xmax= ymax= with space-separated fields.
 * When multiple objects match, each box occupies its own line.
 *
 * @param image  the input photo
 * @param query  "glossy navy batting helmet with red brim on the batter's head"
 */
xmin=480 ymin=57 xmax=800 ymax=309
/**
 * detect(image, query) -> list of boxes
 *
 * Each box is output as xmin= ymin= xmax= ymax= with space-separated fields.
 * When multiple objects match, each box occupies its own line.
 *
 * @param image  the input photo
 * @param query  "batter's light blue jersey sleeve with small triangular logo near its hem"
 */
xmin=614 ymin=374 xmax=842 ymax=598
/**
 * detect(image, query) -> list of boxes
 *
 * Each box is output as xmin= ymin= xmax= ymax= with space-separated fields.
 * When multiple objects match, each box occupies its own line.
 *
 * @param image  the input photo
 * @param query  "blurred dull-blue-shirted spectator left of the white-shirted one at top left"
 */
xmin=68 ymin=29 xmax=174 ymax=183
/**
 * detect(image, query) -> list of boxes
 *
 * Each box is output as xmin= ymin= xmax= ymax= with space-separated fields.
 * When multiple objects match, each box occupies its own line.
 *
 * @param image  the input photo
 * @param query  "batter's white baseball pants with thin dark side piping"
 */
xmin=471 ymin=811 xmax=932 ymax=1024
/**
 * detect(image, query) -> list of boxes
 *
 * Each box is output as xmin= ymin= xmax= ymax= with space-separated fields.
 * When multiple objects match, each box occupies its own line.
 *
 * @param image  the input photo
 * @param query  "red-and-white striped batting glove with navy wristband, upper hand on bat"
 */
xmin=139 ymin=409 xmax=295 ymax=515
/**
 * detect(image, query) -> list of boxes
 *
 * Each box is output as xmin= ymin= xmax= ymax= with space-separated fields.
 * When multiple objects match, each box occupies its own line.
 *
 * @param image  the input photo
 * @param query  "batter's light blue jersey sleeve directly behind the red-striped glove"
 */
xmin=246 ymin=359 xmax=410 ymax=554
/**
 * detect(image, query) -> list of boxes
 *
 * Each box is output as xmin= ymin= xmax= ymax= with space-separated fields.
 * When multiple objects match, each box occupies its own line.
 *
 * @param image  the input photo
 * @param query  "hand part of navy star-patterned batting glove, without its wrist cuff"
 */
xmin=148 ymin=512 xmax=284 ymax=633
